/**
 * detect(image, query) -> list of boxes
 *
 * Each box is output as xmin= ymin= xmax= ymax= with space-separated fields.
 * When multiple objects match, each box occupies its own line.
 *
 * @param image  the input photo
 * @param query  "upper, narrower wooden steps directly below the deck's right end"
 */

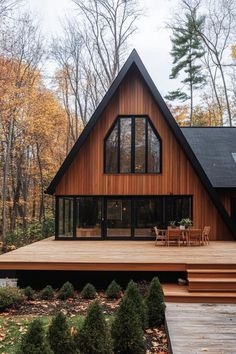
xmin=187 ymin=267 xmax=236 ymax=292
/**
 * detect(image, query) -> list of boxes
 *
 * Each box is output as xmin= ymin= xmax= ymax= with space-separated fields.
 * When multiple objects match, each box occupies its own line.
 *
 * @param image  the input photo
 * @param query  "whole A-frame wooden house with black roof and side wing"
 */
xmin=46 ymin=50 xmax=236 ymax=240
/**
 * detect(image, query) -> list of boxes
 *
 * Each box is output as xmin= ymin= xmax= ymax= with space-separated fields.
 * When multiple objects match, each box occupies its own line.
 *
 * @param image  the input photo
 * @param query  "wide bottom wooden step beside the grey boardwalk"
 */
xmin=163 ymin=284 xmax=236 ymax=304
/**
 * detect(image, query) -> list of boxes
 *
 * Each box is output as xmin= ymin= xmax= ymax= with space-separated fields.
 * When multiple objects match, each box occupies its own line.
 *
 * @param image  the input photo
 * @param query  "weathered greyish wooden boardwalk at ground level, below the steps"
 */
xmin=166 ymin=304 xmax=236 ymax=354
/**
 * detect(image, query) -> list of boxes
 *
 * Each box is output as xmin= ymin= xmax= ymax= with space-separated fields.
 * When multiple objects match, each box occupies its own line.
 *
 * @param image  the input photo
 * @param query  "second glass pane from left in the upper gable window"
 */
xmin=120 ymin=118 xmax=131 ymax=173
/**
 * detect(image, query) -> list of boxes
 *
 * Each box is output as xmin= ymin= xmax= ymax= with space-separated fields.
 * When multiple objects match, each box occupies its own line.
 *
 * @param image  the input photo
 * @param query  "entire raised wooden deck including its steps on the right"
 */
xmin=0 ymin=238 xmax=236 ymax=303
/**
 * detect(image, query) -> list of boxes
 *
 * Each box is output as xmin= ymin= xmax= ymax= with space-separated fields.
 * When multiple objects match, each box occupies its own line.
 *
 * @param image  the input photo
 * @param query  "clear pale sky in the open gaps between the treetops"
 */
xmin=25 ymin=0 xmax=178 ymax=95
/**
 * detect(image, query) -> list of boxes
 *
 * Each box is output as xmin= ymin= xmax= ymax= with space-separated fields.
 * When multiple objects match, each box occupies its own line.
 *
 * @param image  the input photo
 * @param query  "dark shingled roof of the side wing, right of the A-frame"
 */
xmin=181 ymin=127 xmax=236 ymax=188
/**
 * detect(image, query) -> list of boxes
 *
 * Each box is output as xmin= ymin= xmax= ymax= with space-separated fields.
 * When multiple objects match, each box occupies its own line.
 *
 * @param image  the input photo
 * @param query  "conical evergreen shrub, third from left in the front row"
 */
xmin=76 ymin=301 xmax=113 ymax=354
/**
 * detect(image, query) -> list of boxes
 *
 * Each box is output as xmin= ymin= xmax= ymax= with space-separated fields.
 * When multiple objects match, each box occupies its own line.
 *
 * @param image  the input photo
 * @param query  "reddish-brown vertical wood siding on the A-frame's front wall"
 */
xmin=55 ymin=67 xmax=231 ymax=240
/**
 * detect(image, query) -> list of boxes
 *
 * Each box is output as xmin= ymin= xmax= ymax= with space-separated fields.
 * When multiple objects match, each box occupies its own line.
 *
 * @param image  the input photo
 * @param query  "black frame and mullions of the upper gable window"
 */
xmin=103 ymin=114 xmax=162 ymax=175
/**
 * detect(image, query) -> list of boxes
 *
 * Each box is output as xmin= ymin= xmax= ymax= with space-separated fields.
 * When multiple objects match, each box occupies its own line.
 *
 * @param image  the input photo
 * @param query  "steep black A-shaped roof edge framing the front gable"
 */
xmin=46 ymin=49 xmax=236 ymax=238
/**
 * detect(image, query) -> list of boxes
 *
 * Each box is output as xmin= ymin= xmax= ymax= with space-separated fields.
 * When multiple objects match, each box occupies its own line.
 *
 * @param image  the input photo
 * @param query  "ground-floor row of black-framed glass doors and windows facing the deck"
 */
xmin=56 ymin=195 xmax=192 ymax=239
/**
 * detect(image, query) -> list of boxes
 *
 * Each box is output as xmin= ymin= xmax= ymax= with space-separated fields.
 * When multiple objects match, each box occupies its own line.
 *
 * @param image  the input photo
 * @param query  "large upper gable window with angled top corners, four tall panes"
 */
xmin=104 ymin=116 xmax=161 ymax=173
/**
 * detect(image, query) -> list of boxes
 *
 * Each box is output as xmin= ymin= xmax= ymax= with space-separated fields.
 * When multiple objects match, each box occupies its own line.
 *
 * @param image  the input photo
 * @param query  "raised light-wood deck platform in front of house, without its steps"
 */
xmin=0 ymin=238 xmax=236 ymax=271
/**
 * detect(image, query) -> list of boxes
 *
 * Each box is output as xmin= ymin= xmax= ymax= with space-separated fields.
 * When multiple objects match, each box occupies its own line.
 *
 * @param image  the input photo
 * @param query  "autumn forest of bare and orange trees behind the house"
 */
xmin=0 ymin=0 xmax=236 ymax=249
